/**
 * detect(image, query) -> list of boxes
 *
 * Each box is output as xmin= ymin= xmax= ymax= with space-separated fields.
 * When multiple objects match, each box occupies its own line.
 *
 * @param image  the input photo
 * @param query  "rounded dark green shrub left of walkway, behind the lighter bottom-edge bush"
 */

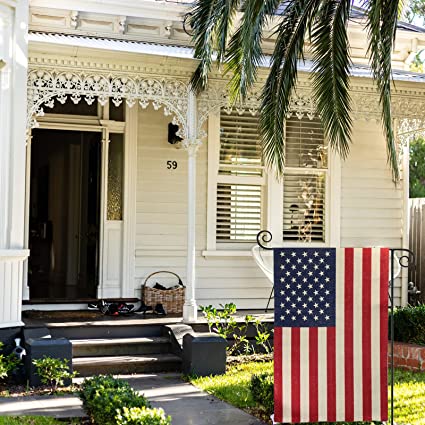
xmin=79 ymin=375 xmax=150 ymax=425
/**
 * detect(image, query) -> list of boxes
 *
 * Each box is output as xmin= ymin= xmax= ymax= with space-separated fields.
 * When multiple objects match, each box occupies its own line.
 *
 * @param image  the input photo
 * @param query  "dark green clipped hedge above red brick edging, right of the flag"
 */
xmin=394 ymin=304 xmax=425 ymax=345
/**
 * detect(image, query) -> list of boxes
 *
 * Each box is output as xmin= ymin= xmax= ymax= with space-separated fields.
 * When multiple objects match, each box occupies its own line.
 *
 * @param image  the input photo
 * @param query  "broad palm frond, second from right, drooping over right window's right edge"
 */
xmin=312 ymin=0 xmax=352 ymax=158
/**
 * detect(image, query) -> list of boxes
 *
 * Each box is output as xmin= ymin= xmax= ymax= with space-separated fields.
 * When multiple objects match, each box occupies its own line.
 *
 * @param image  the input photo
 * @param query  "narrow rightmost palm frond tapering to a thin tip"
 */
xmin=368 ymin=0 xmax=400 ymax=180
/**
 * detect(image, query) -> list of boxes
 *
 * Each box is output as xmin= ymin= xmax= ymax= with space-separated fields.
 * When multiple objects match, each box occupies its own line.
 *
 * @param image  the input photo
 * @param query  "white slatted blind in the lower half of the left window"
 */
xmin=216 ymin=183 xmax=262 ymax=242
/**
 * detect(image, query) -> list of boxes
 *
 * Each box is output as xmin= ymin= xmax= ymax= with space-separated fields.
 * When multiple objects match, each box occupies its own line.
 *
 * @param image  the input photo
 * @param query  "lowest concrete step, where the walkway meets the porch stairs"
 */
xmin=72 ymin=354 xmax=181 ymax=376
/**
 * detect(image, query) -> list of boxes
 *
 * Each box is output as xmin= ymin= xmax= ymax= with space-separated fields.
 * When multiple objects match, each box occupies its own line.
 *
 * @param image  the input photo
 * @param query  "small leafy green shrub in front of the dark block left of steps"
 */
xmin=33 ymin=356 xmax=77 ymax=392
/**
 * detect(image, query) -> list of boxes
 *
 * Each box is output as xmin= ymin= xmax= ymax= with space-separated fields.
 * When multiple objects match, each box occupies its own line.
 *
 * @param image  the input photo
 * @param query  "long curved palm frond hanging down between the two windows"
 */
xmin=260 ymin=0 xmax=320 ymax=177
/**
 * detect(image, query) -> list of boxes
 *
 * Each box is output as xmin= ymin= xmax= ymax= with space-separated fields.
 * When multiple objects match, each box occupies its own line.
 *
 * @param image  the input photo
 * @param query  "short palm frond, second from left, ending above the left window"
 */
xmin=226 ymin=0 xmax=281 ymax=100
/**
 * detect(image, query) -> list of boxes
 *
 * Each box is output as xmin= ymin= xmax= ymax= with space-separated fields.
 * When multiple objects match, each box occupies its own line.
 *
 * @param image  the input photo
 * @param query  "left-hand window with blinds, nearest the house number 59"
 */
xmin=216 ymin=111 xmax=265 ymax=243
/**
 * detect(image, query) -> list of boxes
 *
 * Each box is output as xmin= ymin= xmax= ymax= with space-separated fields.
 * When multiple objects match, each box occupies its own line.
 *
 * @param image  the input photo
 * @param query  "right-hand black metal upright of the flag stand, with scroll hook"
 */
xmin=390 ymin=248 xmax=415 ymax=425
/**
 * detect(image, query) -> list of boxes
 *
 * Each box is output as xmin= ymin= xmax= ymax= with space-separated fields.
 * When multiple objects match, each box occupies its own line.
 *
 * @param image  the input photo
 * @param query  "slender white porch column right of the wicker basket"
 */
xmin=183 ymin=91 xmax=200 ymax=323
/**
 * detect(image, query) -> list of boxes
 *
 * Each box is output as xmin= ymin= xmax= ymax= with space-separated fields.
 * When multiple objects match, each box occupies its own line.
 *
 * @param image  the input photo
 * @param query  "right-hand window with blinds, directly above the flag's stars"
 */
xmin=283 ymin=116 xmax=328 ymax=242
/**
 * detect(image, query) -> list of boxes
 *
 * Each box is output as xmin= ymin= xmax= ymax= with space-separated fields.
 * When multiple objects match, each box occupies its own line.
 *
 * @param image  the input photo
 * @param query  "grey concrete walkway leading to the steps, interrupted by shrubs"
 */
xmin=0 ymin=373 xmax=263 ymax=425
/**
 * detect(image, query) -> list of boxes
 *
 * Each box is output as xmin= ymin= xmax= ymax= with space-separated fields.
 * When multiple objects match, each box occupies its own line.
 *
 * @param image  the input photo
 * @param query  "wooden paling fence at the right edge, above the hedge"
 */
xmin=409 ymin=198 xmax=425 ymax=303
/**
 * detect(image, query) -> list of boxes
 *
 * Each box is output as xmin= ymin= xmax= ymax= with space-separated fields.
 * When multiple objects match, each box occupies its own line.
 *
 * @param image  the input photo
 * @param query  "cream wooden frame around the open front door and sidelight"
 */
xmin=23 ymin=108 xmax=138 ymax=300
